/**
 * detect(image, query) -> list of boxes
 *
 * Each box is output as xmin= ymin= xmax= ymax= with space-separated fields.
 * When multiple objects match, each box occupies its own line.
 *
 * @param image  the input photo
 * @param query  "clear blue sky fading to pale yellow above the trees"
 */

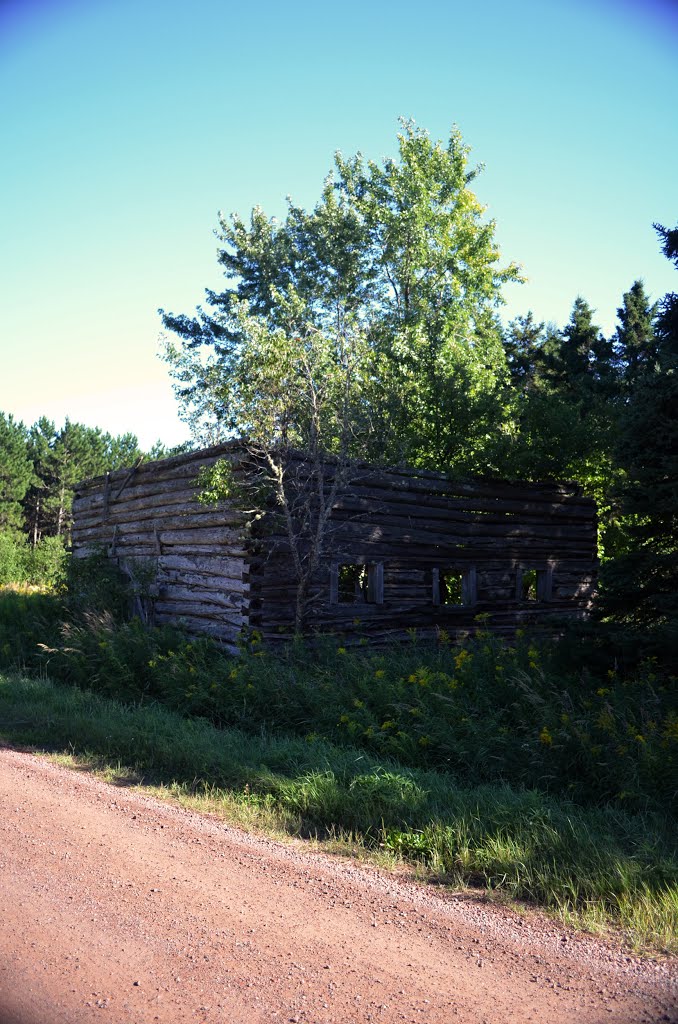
xmin=0 ymin=0 xmax=678 ymax=446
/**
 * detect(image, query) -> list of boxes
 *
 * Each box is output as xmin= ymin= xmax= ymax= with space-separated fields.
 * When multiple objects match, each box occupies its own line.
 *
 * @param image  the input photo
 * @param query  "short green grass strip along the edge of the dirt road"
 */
xmin=0 ymin=675 xmax=678 ymax=952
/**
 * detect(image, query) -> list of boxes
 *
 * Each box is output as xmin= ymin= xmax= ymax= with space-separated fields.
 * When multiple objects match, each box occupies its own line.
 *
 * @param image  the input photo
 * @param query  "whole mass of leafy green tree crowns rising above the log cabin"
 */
xmin=163 ymin=122 xmax=519 ymax=470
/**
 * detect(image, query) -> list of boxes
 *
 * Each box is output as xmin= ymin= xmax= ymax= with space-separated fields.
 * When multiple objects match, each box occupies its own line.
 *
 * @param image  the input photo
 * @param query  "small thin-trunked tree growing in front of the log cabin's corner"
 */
xmin=167 ymin=288 xmax=369 ymax=632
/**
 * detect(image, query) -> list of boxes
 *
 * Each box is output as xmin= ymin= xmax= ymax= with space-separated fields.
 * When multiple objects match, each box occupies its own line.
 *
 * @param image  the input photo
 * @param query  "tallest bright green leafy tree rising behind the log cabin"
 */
xmin=336 ymin=122 xmax=520 ymax=471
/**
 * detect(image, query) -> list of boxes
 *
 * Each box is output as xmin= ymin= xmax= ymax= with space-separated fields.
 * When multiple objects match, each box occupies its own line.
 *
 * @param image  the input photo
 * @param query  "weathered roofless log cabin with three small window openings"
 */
xmin=73 ymin=442 xmax=597 ymax=643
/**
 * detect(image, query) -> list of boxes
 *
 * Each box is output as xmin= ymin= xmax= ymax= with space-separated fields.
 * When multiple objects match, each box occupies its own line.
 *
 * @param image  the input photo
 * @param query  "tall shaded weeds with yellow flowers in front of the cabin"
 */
xmin=0 ymin=593 xmax=678 ymax=816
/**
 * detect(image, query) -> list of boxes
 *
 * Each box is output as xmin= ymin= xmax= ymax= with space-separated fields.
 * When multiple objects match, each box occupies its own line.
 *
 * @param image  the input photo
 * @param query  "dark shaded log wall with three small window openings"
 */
xmin=250 ymin=471 xmax=597 ymax=640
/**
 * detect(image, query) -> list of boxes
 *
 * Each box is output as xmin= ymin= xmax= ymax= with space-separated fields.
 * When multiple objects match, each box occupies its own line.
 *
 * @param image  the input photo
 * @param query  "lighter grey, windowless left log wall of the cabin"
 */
xmin=73 ymin=444 xmax=249 ymax=643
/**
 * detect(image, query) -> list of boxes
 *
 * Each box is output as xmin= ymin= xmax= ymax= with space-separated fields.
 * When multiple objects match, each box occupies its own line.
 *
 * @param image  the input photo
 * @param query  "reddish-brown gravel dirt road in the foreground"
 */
xmin=0 ymin=750 xmax=678 ymax=1024
